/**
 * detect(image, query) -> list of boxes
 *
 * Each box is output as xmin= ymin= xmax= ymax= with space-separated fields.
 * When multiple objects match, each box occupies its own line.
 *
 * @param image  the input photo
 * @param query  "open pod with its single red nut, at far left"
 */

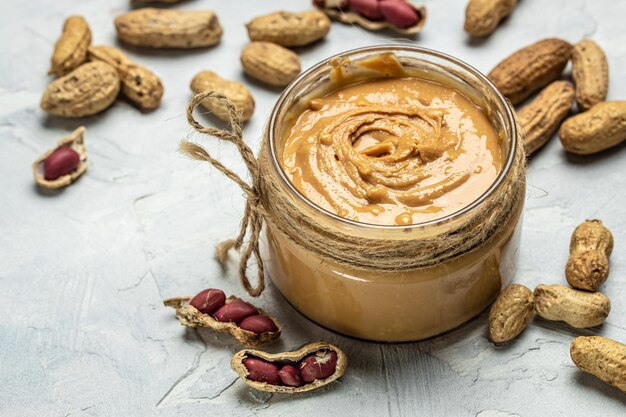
xmin=33 ymin=126 xmax=87 ymax=189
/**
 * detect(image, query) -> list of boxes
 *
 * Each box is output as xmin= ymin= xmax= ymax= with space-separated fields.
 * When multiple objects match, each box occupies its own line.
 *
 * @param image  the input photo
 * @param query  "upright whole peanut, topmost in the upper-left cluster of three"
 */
xmin=48 ymin=16 xmax=91 ymax=77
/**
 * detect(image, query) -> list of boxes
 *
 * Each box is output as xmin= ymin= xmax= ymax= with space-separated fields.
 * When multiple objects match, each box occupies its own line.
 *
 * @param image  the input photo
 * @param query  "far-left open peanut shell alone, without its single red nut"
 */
xmin=33 ymin=126 xmax=87 ymax=189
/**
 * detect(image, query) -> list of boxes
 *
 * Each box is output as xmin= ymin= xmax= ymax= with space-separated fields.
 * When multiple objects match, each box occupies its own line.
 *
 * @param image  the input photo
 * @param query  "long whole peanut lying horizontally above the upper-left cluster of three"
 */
xmin=115 ymin=7 xmax=223 ymax=49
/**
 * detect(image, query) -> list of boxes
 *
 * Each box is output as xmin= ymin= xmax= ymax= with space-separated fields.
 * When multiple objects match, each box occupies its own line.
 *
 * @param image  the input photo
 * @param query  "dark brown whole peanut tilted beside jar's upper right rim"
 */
xmin=488 ymin=38 xmax=572 ymax=104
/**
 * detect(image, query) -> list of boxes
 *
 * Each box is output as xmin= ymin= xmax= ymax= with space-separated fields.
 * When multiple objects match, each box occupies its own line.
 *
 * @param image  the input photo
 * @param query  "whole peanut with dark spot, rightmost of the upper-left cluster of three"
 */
xmin=89 ymin=45 xmax=163 ymax=110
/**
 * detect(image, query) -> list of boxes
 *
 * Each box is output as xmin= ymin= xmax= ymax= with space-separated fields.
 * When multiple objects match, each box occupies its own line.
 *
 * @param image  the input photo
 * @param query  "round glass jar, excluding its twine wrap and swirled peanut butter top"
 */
xmin=262 ymin=45 xmax=525 ymax=342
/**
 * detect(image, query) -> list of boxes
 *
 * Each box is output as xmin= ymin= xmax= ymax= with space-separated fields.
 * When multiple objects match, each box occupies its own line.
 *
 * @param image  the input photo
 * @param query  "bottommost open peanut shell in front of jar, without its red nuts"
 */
xmin=230 ymin=342 xmax=348 ymax=394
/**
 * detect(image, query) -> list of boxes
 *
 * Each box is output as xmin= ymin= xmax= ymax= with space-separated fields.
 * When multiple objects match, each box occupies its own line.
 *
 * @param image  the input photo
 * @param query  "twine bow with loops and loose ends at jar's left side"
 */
xmin=180 ymin=91 xmax=265 ymax=297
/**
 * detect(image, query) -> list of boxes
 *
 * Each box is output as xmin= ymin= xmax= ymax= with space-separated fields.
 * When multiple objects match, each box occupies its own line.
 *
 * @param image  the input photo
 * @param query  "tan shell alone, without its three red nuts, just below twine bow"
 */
xmin=163 ymin=295 xmax=283 ymax=347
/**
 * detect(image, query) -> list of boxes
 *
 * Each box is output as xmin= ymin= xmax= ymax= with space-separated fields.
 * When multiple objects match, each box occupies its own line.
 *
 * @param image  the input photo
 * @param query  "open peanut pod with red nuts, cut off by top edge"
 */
xmin=313 ymin=0 xmax=426 ymax=35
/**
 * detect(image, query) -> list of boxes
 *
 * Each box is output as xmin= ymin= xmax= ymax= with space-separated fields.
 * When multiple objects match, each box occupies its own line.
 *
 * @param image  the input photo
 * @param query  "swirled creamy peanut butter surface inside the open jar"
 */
xmin=282 ymin=77 xmax=502 ymax=225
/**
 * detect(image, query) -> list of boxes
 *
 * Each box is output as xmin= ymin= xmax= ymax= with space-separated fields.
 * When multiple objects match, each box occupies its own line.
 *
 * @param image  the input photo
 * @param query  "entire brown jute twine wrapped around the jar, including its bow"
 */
xmin=180 ymin=91 xmax=525 ymax=297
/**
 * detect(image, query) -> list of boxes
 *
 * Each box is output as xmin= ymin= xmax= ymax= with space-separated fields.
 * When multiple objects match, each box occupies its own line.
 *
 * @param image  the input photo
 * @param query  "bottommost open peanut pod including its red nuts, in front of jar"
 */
xmin=231 ymin=342 xmax=347 ymax=394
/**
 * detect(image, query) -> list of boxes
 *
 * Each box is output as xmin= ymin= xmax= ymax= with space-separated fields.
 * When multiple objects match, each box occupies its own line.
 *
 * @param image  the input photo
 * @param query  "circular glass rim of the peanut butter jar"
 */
xmin=268 ymin=44 xmax=519 ymax=230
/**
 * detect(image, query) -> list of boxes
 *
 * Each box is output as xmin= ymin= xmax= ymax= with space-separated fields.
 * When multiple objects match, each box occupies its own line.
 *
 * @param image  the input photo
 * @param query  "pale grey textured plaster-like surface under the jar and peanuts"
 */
xmin=0 ymin=0 xmax=626 ymax=417
